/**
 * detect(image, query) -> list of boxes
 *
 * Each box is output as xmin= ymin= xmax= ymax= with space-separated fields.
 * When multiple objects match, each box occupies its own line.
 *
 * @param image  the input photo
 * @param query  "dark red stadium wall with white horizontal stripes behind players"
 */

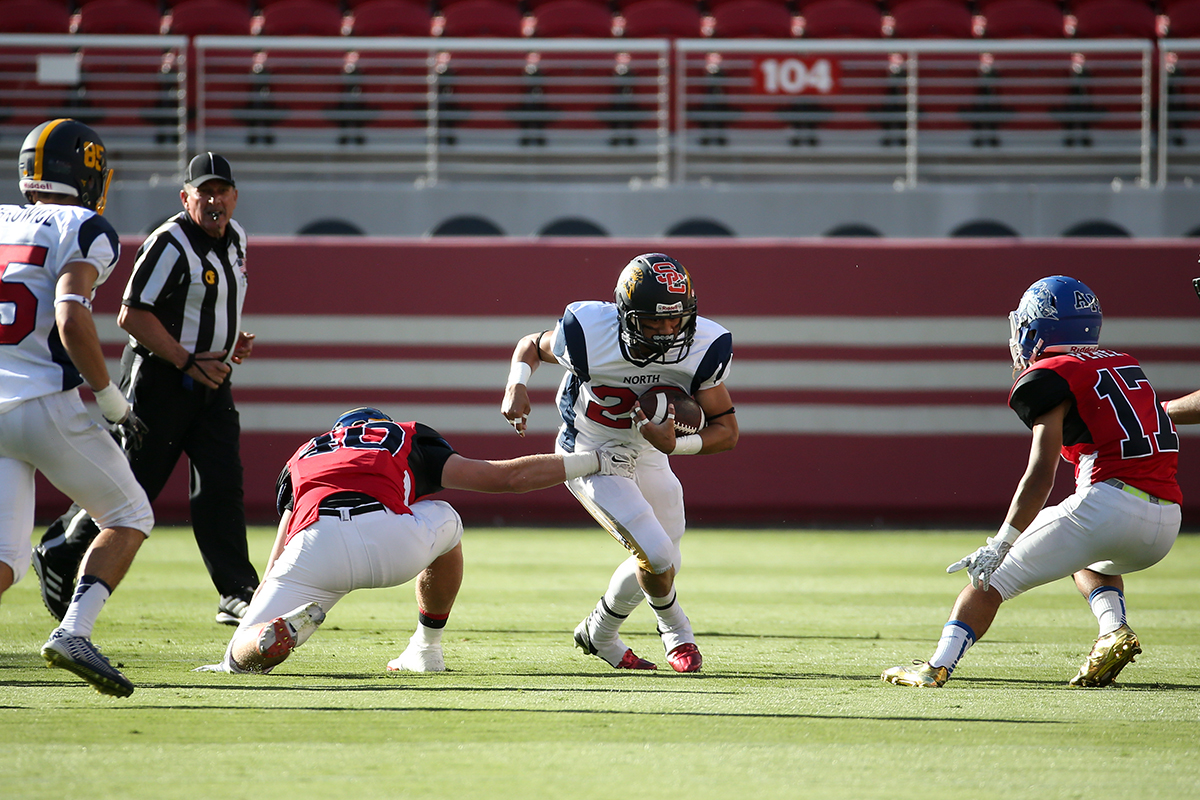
xmin=37 ymin=237 xmax=1200 ymax=525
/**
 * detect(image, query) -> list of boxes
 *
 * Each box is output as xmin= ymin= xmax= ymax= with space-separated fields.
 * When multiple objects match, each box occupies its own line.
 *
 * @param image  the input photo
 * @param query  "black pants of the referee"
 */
xmin=120 ymin=347 xmax=258 ymax=597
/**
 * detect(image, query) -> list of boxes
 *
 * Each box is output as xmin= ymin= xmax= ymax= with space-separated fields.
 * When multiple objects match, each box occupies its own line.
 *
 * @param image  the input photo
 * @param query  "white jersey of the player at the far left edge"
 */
xmin=0 ymin=204 xmax=121 ymax=411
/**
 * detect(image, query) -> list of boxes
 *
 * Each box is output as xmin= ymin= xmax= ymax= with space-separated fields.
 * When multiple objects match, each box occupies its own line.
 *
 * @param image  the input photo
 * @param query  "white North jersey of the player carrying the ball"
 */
xmin=553 ymin=300 xmax=733 ymax=452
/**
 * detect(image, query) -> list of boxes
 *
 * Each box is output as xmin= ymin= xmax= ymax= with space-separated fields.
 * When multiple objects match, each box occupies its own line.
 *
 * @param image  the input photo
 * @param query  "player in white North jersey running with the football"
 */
xmin=500 ymin=253 xmax=738 ymax=673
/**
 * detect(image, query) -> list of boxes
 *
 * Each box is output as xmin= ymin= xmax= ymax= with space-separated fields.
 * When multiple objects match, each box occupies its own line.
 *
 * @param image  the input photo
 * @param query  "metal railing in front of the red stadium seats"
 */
xmin=0 ymin=35 xmax=1185 ymax=186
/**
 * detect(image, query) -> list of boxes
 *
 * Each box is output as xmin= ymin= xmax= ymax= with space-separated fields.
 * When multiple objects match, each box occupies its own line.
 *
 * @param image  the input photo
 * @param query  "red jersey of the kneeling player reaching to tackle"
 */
xmin=280 ymin=421 xmax=454 ymax=539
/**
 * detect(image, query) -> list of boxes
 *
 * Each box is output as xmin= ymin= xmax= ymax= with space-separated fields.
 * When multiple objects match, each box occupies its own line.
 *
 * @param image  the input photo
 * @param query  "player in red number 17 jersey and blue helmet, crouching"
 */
xmin=882 ymin=276 xmax=1182 ymax=688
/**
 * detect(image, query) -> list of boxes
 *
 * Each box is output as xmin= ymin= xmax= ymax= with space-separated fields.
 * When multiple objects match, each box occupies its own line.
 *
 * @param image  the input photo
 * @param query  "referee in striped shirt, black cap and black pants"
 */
xmin=34 ymin=152 xmax=258 ymax=625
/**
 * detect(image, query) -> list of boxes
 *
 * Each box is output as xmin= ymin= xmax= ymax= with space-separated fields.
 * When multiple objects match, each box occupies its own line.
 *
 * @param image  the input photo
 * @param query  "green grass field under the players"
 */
xmin=0 ymin=528 xmax=1200 ymax=800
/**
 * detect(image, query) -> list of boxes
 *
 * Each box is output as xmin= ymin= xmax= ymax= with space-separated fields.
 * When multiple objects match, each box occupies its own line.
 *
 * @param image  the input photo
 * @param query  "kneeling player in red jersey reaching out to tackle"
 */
xmin=197 ymin=408 xmax=635 ymax=673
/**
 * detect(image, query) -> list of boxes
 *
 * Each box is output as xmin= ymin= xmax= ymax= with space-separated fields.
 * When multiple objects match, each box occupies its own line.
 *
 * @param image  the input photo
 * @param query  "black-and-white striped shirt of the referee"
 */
xmin=121 ymin=211 xmax=246 ymax=361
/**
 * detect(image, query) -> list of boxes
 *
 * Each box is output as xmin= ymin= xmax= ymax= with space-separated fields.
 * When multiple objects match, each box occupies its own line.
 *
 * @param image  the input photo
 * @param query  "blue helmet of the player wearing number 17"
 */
xmin=1008 ymin=275 xmax=1104 ymax=372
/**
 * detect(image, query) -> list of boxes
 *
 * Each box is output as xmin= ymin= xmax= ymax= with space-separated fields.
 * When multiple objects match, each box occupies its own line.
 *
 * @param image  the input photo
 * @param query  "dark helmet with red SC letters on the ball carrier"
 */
xmin=613 ymin=253 xmax=696 ymax=367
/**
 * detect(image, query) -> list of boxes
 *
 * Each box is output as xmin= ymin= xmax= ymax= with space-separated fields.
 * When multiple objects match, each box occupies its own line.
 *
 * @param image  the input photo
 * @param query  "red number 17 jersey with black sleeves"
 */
xmin=1008 ymin=350 xmax=1183 ymax=503
